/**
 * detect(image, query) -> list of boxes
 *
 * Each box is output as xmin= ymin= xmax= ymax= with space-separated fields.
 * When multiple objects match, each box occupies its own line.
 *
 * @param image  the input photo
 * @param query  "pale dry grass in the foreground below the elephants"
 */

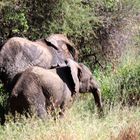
xmin=0 ymin=101 xmax=140 ymax=140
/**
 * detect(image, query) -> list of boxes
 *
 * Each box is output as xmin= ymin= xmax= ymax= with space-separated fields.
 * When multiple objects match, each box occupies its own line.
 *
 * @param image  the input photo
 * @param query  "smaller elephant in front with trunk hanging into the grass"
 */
xmin=8 ymin=59 xmax=103 ymax=118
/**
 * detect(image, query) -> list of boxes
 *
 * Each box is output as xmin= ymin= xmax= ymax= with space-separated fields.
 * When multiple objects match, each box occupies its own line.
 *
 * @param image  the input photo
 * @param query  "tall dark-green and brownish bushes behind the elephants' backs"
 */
xmin=0 ymin=0 xmax=140 ymax=69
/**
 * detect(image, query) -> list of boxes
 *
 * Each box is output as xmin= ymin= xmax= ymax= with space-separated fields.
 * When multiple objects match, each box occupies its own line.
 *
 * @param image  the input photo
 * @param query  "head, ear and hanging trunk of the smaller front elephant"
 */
xmin=67 ymin=59 xmax=103 ymax=115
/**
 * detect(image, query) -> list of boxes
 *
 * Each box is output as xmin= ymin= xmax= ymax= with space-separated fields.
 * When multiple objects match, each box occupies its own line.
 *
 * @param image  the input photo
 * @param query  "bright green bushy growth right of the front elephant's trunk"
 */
xmin=98 ymin=48 xmax=140 ymax=105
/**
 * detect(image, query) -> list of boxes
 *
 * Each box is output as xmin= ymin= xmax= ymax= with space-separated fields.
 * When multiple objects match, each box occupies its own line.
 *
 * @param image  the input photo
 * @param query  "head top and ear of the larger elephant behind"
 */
xmin=45 ymin=34 xmax=78 ymax=60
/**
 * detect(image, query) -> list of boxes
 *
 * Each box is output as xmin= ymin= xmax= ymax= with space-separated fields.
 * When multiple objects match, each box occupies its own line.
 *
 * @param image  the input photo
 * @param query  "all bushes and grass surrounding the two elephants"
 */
xmin=0 ymin=0 xmax=140 ymax=140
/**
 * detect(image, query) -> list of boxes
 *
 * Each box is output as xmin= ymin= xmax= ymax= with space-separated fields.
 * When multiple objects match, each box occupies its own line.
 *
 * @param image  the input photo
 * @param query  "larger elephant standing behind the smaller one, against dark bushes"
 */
xmin=0 ymin=34 xmax=77 ymax=90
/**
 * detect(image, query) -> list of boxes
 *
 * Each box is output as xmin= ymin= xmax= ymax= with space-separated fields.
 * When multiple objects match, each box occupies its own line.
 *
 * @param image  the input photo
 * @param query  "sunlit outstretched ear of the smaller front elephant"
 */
xmin=67 ymin=59 xmax=81 ymax=93
